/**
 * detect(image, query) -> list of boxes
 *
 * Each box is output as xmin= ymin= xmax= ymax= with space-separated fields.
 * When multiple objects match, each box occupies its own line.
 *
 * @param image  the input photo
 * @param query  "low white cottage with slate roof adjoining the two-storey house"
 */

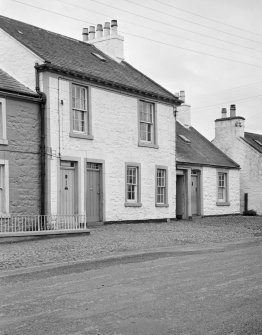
xmin=176 ymin=98 xmax=240 ymax=219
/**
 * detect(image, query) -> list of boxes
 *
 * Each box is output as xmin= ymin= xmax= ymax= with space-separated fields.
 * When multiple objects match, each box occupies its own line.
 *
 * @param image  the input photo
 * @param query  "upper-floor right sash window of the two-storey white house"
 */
xmin=138 ymin=100 xmax=158 ymax=149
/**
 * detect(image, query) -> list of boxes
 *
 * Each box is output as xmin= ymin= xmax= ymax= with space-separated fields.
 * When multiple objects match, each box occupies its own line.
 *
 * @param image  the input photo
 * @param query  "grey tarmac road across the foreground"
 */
xmin=0 ymin=241 xmax=262 ymax=335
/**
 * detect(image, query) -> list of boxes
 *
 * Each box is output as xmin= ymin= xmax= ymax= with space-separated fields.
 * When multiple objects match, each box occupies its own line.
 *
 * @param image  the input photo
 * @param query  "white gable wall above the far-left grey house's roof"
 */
xmin=0 ymin=29 xmax=43 ymax=91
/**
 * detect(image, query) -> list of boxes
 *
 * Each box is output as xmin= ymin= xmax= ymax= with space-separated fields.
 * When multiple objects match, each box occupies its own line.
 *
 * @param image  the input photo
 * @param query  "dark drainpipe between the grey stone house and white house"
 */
xmin=35 ymin=63 xmax=46 ymax=215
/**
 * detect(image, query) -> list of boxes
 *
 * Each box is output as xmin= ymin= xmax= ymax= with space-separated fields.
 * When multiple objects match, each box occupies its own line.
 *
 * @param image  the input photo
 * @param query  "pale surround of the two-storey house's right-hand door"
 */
xmin=84 ymin=158 xmax=105 ymax=222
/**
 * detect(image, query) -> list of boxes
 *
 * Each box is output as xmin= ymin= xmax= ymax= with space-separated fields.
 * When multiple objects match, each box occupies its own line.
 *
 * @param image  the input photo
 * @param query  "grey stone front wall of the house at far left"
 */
xmin=0 ymin=97 xmax=40 ymax=215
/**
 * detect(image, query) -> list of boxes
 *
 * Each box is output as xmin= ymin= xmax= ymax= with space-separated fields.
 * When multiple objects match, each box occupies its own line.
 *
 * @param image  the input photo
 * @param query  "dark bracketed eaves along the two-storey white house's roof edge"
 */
xmin=35 ymin=61 xmax=180 ymax=105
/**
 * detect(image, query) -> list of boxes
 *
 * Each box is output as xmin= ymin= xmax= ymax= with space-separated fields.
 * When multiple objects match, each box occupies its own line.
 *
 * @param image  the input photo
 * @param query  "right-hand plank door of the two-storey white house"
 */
xmin=86 ymin=162 xmax=102 ymax=222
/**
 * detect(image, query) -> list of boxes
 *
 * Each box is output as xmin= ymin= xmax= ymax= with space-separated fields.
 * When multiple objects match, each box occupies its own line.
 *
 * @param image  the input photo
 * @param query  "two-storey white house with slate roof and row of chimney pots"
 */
xmin=0 ymin=16 xmax=180 ymax=222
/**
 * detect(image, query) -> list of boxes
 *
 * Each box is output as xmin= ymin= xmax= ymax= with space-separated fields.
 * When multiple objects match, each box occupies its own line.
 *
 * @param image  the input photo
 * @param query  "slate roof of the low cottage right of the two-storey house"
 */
xmin=176 ymin=122 xmax=239 ymax=168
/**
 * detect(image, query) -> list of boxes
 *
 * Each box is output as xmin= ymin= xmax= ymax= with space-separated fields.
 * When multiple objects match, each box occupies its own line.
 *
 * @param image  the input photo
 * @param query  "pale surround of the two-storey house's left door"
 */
xmin=57 ymin=156 xmax=81 ymax=215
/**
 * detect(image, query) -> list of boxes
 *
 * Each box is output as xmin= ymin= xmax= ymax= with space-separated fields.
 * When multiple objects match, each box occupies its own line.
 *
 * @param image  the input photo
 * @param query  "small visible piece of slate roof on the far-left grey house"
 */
xmin=0 ymin=69 xmax=39 ymax=97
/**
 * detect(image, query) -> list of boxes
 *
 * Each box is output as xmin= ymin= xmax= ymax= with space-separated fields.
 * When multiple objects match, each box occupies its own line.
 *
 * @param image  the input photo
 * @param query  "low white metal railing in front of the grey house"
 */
xmin=0 ymin=215 xmax=87 ymax=233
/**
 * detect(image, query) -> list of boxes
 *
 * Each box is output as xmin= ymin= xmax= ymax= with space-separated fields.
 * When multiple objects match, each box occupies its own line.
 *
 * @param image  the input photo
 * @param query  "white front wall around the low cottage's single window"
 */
xmin=203 ymin=167 xmax=240 ymax=215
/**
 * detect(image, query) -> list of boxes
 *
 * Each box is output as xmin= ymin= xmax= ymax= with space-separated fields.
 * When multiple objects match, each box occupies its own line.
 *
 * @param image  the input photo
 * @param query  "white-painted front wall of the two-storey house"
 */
xmin=49 ymin=75 xmax=176 ymax=221
